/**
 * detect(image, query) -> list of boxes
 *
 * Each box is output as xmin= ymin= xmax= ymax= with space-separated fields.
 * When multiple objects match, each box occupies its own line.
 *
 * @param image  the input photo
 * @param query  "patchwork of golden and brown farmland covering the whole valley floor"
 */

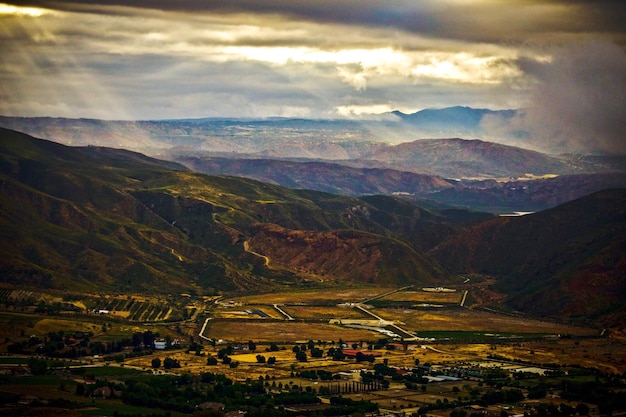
xmin=0 ymin=288 xmax=626 ymax=417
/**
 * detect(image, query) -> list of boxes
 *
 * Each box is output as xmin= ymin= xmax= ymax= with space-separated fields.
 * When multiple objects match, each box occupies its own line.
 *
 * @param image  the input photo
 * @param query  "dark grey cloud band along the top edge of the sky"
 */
xmin=22 ymin=0 xmax=626 ymax=46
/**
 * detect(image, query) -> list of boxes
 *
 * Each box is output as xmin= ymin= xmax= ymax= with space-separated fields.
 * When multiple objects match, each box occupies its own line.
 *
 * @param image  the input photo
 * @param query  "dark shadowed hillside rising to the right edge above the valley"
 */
xmin=428 ymin=189 xmax=626 ymax=324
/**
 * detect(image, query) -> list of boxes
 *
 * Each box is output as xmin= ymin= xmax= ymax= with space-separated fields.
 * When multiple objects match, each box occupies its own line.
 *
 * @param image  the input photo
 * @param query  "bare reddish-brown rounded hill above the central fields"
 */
xmin=247 ymin=224 xmax=448 ymax=286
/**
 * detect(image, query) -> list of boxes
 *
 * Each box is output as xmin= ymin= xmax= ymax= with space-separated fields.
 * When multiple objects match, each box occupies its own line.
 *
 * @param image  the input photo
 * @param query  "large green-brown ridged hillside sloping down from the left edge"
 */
xmin=0 ymin=129 xmax=458 ymax=293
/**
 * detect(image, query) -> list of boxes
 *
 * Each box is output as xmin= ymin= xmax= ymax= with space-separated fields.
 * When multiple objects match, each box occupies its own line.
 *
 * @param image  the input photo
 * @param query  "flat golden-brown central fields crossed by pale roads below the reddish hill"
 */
xmin=202 ymin=288 xmax=599 ymax=343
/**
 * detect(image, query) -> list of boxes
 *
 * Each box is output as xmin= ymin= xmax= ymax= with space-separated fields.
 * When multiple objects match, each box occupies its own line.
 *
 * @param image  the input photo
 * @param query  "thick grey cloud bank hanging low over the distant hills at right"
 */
xmin=483 ymin=41 xmax=626 ymax=154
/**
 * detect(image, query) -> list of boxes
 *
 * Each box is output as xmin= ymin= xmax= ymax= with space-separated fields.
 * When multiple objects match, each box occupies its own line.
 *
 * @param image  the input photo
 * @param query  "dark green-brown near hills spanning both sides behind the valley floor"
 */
xmin=0 ymin=129 xmax=626 ymax=325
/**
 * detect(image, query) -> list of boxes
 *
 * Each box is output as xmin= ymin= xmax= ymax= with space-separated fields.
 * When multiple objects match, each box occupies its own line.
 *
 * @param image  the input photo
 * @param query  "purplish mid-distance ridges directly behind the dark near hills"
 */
xmin=174 ymin=151 xmax=626 ymax=213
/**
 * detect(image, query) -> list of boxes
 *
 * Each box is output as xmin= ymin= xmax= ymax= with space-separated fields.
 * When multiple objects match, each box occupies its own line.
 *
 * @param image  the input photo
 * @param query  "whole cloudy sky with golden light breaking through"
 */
xmin=0 ymin=0 xmax=626 ymax=153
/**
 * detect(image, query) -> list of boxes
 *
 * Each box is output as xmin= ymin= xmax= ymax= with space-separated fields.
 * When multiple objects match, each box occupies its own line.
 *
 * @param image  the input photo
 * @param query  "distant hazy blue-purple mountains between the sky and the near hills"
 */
xmin=0 ymin=106 xmax=626 ymax=214
